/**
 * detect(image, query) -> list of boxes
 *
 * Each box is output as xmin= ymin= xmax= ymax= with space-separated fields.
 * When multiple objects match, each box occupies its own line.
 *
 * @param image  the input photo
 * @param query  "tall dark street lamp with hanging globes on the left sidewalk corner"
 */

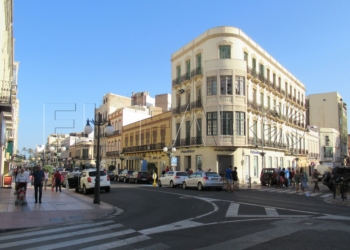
xmin=84 ymin=113 xmax=113 ymax=204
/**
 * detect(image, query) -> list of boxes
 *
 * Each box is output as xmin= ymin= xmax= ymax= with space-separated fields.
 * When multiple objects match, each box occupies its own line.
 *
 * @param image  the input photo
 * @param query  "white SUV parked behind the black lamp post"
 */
xmin=75 ymin=168 xmax=111 ymax=194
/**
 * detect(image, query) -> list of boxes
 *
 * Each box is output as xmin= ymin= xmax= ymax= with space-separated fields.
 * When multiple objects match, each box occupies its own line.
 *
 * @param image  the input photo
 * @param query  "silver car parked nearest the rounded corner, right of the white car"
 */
xmin=182 ymin=171 xmax=224 ymax=191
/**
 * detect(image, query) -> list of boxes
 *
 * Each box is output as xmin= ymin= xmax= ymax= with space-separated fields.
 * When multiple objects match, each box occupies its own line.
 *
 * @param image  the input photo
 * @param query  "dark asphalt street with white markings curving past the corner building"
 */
xmin=0 ymin=182 xmax=350 ymax=249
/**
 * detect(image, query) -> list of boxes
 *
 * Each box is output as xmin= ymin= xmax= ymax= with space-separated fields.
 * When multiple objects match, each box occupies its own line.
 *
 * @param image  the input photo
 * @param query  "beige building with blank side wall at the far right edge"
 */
xmin=308 ymin=92 xmax=349 ymax=166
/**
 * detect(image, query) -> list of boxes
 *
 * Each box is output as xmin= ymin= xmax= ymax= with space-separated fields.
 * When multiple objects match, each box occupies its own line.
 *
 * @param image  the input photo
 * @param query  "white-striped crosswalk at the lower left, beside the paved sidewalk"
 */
xmin=0 ymin=220 xmax=168 ymax=250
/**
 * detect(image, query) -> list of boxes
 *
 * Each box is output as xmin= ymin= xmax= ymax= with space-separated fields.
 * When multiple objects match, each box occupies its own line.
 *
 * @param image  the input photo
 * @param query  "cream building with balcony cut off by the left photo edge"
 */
xmin=0 ymin=0 xmax=19 ymax=186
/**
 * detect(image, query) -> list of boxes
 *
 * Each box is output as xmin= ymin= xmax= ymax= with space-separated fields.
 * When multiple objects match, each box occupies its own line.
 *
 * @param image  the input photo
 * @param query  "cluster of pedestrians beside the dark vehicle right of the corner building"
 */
xmin=276 ymin=168 xmax=320 ymax=193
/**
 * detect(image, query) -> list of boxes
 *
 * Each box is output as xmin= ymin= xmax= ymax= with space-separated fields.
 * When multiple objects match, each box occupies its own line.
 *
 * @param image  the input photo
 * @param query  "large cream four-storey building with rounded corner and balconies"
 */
xmin=171 ymin=26 xmax=306 ymax=184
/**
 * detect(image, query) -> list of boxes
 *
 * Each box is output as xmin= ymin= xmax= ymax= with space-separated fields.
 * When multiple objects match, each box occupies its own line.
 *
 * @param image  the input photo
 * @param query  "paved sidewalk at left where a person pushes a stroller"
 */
xmin=0 ymin=183 xmax=120 ymax=231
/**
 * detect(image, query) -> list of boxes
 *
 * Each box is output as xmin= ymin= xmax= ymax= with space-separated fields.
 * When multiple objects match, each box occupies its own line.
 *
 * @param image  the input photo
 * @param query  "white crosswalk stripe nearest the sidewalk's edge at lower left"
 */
xmin=0 ymin=220 xmax=114 ymax=241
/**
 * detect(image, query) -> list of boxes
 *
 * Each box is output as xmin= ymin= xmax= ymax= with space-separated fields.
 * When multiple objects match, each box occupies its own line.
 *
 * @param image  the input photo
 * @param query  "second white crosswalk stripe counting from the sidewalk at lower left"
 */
xmin=0 ymin=224 xmax=123 ymax=249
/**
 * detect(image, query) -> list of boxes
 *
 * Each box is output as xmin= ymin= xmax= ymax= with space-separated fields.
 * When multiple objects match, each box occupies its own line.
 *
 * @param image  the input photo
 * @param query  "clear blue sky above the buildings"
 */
xmin=13 ymin=0 xmax=350 ymax=153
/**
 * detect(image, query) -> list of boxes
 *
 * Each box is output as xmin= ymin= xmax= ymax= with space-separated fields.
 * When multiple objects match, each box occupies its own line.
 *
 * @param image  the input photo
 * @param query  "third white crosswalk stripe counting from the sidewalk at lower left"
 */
xmin=24 ymin=229 xmax=136 ymax=250
